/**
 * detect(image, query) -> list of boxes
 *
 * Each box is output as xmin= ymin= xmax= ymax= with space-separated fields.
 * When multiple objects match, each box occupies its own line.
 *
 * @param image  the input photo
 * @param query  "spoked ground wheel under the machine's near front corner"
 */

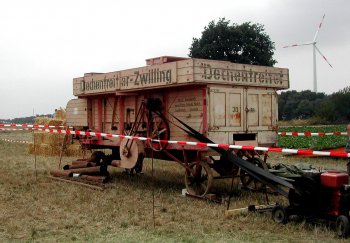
xmin=185 ymin=161 xmax=213 ymax=197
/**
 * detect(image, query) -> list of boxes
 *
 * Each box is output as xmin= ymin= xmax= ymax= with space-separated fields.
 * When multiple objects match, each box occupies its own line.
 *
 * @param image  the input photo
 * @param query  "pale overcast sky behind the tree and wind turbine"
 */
xmin=0 ymin=0 xmax=350 ymax=119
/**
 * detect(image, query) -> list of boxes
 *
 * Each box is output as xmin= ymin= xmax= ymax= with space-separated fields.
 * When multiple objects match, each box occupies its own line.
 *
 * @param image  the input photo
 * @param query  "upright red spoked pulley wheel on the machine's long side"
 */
xmin=147 ymin=112 xmax=170 ymax=152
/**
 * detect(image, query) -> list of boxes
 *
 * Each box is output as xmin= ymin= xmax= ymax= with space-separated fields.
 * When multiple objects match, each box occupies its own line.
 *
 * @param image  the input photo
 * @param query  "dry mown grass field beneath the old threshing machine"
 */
xmin=0 ymin=133 xmax=346 ymax=242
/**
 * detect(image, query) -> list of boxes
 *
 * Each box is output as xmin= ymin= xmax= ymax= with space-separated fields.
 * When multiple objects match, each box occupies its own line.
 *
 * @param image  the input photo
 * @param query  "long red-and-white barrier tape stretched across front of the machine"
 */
xmin=30 ymin=128 xmax=350 ymax=158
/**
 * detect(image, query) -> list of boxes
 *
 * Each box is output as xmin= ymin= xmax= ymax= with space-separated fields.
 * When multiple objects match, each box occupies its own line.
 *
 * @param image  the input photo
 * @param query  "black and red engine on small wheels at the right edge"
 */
xmin=272 ymin=171 xmax=350 ymax=238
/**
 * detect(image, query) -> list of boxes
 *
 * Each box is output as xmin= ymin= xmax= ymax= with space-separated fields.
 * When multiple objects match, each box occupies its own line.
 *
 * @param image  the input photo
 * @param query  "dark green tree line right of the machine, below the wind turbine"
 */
xmin=278 ymin=86 xmax=350 ymax=123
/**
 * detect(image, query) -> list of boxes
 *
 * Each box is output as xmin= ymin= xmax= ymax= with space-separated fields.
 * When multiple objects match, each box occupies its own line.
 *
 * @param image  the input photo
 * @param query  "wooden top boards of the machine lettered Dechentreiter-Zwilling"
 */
xmin=73 ymin=56 xmax=289 ymax=96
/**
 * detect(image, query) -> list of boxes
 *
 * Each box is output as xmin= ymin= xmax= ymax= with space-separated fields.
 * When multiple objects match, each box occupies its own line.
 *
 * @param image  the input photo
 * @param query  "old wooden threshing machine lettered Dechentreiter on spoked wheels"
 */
xmin=67 ymin=56 xmax=289 ymax=196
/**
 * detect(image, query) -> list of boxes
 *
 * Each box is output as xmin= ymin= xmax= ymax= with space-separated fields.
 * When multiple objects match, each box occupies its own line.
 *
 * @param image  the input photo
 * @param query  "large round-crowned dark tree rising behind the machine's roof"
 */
xmin=189 ymin=18 xmax=276 ymax=66
